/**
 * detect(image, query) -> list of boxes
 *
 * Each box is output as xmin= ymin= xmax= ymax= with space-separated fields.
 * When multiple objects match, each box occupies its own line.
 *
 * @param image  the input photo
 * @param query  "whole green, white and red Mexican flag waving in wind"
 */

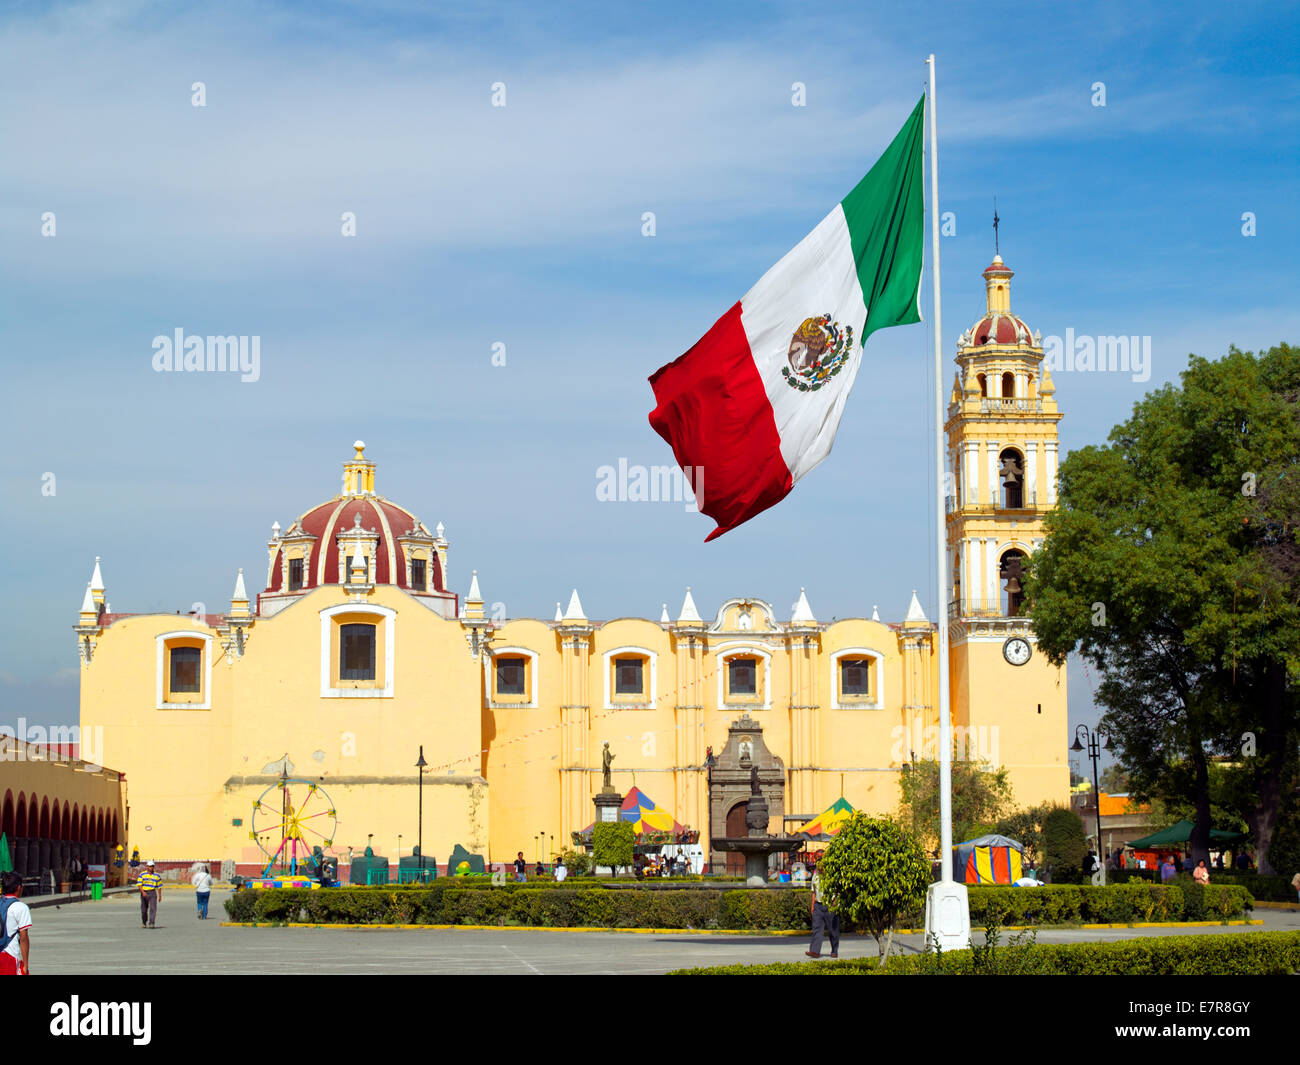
xmin=650 ymin=98 xmax=926 ymax=541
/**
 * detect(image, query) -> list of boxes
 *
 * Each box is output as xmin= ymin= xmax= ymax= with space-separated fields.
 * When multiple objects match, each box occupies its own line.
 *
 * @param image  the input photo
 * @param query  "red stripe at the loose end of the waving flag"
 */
xmin=650 ymin=303 xmax=793 ymax=544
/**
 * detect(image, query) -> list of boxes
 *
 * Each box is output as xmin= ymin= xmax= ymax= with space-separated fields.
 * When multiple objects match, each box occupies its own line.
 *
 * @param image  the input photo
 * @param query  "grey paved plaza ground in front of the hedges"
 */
xmin=22 ymin=889 xmax=1300 ymax=975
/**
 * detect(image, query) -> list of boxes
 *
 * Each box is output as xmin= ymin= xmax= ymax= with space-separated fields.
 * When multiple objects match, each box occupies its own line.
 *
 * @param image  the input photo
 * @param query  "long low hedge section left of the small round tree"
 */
xmin=226 ymin=884 xmax=811 ymax=930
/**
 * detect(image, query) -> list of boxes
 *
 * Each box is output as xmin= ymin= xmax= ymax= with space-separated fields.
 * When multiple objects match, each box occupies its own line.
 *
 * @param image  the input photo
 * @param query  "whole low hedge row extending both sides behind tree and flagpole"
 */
xmin=226 ymin=880 xmax=1251 ymax=930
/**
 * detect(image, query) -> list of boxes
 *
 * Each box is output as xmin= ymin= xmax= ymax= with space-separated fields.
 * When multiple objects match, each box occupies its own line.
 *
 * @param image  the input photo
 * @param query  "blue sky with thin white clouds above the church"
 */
xmin=0 ymin=3 xmax=1300 ymax=769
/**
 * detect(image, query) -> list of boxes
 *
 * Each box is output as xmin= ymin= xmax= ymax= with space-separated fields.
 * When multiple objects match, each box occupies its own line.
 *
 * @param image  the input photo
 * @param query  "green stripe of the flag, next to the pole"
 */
xmin=840 ymin=96 xmax=926 ymax=345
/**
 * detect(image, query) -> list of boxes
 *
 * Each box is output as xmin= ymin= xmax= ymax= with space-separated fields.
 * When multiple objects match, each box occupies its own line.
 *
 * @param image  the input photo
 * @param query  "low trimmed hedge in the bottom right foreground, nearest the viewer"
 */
xmin=670 ymin=932 xmax=1300 ymax=977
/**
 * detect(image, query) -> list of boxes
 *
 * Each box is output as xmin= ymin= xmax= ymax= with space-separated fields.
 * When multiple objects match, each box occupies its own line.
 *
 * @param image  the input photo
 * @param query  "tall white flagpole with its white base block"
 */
xmin=926 ymin=55 xmax=971 ymax=951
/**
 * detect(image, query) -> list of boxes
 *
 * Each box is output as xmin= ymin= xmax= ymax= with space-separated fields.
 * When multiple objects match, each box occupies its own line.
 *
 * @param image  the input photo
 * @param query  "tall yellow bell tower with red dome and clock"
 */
xmin=945 ymin=255 xmax=1070 ymax=806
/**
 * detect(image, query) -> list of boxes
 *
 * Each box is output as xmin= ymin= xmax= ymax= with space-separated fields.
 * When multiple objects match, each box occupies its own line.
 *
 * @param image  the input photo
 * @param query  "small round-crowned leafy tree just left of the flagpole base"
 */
xmin=818 ymin=810 xmax=932 ymax=960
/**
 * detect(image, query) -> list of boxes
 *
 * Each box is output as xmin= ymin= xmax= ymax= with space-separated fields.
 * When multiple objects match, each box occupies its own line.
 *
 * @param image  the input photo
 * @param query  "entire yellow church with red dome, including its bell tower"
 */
xmin=75 ymin=257 xmax=1069 ymax=871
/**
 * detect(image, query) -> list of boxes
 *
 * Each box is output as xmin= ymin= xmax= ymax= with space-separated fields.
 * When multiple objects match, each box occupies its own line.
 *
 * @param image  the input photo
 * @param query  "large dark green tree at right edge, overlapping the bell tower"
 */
xmin=1027 ymin=345 xmax=1300 ymax=869
